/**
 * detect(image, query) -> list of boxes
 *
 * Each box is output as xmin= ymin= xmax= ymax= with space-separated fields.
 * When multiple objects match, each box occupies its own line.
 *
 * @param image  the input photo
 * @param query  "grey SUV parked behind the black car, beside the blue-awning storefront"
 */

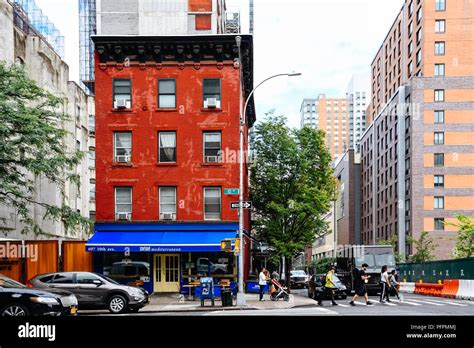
xmin=29 ymin=272 xmax=150 ymax=313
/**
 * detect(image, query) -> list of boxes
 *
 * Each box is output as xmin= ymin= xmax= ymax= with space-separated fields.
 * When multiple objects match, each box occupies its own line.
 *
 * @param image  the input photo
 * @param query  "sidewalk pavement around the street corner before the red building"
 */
xmin=140 ymin=294 xmax=316 ymax=312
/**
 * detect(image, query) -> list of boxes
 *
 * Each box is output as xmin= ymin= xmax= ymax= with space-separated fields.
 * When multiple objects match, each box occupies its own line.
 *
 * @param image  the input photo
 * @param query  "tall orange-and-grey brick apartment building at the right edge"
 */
xmin=361 ymin=0 xmax=474 ymax=258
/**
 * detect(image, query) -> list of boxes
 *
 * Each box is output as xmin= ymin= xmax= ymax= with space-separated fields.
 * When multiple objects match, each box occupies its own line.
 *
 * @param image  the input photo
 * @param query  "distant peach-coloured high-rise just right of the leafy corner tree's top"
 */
xmin=300 ymin=94 xmax=349 ymax=158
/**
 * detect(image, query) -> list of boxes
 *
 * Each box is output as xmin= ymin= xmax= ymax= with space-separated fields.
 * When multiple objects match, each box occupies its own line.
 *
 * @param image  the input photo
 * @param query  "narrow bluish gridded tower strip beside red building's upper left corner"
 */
xmin=79 ymin=0 xmax=97 ymax=94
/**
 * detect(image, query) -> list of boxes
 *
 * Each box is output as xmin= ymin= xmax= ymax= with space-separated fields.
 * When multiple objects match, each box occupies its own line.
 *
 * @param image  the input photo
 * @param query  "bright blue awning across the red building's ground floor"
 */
xmin=86 ymin=223 xmax=239 ymax=253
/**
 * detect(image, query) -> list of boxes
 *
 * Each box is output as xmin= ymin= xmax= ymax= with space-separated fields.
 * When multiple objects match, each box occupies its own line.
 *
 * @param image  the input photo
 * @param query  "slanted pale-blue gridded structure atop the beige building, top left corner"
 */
xmin=14 ymin=0 xmax=65 ymax=59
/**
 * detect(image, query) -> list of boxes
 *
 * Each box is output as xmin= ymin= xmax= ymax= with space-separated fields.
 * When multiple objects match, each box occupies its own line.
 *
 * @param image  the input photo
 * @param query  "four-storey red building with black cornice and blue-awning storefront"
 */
xmin=87 ymin=35 xmax=255 ymax=292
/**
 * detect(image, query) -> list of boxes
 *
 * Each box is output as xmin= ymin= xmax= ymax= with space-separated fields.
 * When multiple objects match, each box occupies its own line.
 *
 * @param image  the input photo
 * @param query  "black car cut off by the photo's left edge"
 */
xmin=0 ymin=274 xmax=77 ymax=317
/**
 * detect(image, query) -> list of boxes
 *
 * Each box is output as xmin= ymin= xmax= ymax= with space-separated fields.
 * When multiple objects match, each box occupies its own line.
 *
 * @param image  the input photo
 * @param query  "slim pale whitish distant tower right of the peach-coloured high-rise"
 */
xmin=347 ymin=74 xmax=370 ymax=152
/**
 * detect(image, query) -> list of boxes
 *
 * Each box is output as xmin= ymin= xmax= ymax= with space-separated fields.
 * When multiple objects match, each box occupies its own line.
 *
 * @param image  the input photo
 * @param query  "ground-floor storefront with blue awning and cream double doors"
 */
xmin=86 ymin=222 xmax=238 ymax=294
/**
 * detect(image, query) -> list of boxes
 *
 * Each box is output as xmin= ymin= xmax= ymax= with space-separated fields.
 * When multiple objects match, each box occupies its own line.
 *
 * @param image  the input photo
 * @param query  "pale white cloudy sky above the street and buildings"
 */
xmin=36 ymin=0 xmax=404 ymax=127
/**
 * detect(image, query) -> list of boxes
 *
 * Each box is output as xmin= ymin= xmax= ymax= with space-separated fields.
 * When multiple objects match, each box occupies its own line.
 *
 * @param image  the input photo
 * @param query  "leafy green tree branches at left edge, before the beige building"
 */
xmin=0 ymin=62 xmax=90 ymax=234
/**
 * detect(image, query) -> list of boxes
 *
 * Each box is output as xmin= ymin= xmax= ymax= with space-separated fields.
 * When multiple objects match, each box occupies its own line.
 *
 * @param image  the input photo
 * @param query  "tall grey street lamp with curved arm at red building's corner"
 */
xmin=235 ymin=36 xmax=301 ymax=306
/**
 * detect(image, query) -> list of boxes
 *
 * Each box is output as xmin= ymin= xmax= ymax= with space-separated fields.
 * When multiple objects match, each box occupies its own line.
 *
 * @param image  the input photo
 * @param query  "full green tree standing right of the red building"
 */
xmin=250 ymin=115 xmax=336 ymax=290
